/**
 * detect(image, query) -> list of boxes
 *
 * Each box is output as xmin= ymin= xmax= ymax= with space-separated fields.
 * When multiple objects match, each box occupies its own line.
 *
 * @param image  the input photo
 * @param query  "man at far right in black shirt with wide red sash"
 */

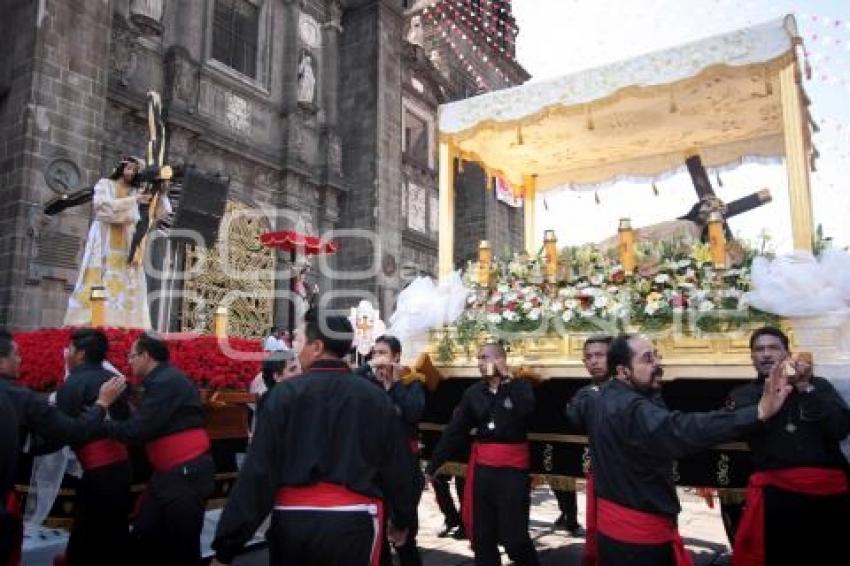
xmin=730 ymin=327 xmax=850 ymax=566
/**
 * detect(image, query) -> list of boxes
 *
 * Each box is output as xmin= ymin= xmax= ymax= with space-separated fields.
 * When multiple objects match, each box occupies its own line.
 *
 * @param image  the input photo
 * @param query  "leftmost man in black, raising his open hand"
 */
xmin=0 ymin=331 xmax=124 ymax=566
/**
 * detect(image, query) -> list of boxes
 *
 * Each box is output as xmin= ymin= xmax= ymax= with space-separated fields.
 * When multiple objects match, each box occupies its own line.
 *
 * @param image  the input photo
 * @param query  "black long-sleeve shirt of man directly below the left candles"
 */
xmin=428 ymin=379 xmax=534 ymax=476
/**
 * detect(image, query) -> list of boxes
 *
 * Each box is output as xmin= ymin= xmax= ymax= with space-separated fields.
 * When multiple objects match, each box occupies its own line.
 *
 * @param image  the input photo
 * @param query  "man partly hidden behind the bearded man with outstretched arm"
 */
xmin=566 ymin=335 xmax=611 ymax=566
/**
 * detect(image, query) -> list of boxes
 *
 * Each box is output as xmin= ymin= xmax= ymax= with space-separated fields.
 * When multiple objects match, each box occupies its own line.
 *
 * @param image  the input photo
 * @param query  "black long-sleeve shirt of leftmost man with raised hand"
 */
xmin=0 ymin=376 xmax=105 ymax=453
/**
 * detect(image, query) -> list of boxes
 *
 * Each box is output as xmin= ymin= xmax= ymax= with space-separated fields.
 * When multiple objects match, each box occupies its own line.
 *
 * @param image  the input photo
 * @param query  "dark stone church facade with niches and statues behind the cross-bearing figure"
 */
xmin=0 ymin=0 xmax=522 ymax=334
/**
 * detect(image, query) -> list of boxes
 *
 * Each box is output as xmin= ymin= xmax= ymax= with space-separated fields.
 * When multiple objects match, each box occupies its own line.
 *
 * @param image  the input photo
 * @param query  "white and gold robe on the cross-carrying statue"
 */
xmin=64 ymin=179 xmax=171 ymax=329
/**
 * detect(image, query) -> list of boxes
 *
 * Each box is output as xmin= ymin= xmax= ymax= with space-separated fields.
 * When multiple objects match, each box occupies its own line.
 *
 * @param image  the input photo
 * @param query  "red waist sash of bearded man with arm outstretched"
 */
xmin=596 ymin=497 xmax=693 ymax=566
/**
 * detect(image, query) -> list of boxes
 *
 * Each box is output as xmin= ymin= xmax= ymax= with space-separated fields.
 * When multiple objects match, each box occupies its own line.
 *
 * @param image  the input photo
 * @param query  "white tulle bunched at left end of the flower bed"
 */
xmin=387 ymin=271 xmax=469 ymax=360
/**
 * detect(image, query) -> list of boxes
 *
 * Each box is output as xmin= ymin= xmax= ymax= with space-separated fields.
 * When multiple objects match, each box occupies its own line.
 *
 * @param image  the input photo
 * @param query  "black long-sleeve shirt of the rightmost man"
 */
xmin=729 ymin=377 xmax=850 ymax=470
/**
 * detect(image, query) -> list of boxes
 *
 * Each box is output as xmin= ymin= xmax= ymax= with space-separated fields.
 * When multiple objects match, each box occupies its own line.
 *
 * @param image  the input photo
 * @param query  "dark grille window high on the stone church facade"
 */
xmin=213 ymin=0 xmax=260 ymax=78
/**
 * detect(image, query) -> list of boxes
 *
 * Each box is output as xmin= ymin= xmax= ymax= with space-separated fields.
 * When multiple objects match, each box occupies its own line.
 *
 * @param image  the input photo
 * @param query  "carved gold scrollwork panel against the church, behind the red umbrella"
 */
xmin=182 ymin=201 xmax=275 ymax=338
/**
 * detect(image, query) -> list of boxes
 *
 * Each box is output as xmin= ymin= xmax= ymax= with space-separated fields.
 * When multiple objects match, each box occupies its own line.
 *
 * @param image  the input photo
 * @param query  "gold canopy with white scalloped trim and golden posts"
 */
xmin=440 ymin=16 xmax=812 ymax=276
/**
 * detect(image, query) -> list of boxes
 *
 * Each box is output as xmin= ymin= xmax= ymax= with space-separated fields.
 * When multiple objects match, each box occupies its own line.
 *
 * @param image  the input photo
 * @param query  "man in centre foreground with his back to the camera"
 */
xmin=213 ymin=309 xmax=419 ymax=566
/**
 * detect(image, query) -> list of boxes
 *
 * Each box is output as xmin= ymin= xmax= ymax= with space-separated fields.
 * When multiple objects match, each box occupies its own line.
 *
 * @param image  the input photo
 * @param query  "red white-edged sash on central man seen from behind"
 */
xmin=275 ymin=482 xmax=384 ymax=566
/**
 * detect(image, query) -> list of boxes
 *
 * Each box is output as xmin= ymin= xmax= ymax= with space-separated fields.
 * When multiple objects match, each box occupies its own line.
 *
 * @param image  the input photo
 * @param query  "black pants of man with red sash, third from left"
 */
xmin=131 ymin=454 xmax=215 ymax=566
